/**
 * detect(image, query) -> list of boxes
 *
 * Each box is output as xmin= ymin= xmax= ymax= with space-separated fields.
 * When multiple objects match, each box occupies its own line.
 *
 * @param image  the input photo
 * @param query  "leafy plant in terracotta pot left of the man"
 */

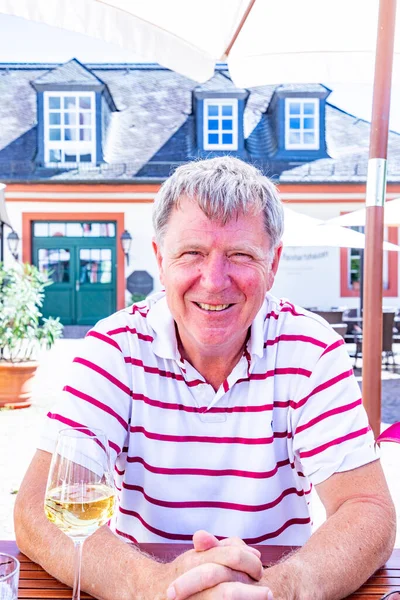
xmin=0 ymin=263 xmax=63 ymax=408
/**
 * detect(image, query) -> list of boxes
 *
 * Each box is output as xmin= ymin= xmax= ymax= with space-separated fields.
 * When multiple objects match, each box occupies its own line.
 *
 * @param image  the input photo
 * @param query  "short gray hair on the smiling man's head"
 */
xmin=153 ymin=156 xmax=284 ymax=251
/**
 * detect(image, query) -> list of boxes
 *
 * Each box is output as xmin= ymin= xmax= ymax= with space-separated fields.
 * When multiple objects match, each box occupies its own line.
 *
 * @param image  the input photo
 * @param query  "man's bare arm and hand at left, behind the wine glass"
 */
xmin=14 ymin=450 xmax=262 ymax=600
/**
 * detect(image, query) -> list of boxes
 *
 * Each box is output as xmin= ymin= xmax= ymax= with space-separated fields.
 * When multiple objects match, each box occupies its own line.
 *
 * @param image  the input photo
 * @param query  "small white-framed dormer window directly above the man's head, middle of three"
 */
xmin=203 ymin=98 xmax=238 ymax=150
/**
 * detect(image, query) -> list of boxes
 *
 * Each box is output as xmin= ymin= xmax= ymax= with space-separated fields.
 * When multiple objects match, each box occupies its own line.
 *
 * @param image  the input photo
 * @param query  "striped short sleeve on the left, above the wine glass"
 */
xmin=38 ymin=319 xmax=132 ymax=460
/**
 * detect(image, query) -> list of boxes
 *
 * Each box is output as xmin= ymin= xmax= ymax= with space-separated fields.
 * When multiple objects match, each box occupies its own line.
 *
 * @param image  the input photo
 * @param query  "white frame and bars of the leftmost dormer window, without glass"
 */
xmin=43 ymin=91 xmax=96 ymax=168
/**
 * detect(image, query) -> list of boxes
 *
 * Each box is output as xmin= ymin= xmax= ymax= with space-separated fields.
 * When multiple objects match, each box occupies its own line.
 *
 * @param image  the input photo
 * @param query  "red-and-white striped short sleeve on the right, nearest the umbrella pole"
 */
xmin=290 ymin=334 xmax=378 ymax=484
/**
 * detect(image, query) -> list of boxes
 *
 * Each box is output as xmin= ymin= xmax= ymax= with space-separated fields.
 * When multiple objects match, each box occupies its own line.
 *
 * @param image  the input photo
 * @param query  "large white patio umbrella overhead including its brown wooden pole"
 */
xmin=0 ymin=0 xmax=400 ymax=436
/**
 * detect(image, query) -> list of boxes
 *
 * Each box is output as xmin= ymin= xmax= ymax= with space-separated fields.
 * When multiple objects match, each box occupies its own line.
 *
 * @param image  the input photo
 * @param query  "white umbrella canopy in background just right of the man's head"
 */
xmin=282 ymin=206 xmax=400 ymax=252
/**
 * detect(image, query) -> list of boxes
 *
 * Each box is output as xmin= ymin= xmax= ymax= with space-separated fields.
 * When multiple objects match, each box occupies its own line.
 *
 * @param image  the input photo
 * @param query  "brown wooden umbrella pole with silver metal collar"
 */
xmin=362 ymin=0 xmax=396 ymax=437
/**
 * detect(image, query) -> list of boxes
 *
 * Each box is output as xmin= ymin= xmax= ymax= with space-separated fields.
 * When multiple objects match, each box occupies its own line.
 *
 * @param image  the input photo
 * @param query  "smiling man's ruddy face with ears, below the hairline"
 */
xmin=153 ymin=198 xmax=281 ymax=358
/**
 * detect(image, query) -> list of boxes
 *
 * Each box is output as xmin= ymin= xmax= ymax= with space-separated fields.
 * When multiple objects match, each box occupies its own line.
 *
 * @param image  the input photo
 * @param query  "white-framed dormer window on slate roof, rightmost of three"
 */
xmin=285 ymin=98 xmax=319 ymax=150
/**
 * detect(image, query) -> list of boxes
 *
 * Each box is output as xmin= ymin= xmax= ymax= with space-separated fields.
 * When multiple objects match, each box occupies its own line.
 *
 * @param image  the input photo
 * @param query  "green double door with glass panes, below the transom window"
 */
xmin=33 ymin=224 xmax=116 ymax=325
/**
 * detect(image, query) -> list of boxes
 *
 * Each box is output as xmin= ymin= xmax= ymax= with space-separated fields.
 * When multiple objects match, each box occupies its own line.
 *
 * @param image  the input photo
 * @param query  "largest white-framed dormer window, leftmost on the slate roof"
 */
xmin=44 ymin=92 xmax=96 ymax=166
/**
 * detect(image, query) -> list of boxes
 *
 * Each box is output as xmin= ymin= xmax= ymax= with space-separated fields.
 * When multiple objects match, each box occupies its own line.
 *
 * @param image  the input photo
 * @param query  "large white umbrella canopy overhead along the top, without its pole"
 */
xmin=0 ymin=0 xmax=400 ymax=87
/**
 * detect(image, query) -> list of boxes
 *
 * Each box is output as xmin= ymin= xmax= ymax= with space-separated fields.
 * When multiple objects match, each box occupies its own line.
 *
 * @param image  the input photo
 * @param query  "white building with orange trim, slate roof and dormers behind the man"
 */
xmin=0 ymin=59 xmax=400 ymax=325
